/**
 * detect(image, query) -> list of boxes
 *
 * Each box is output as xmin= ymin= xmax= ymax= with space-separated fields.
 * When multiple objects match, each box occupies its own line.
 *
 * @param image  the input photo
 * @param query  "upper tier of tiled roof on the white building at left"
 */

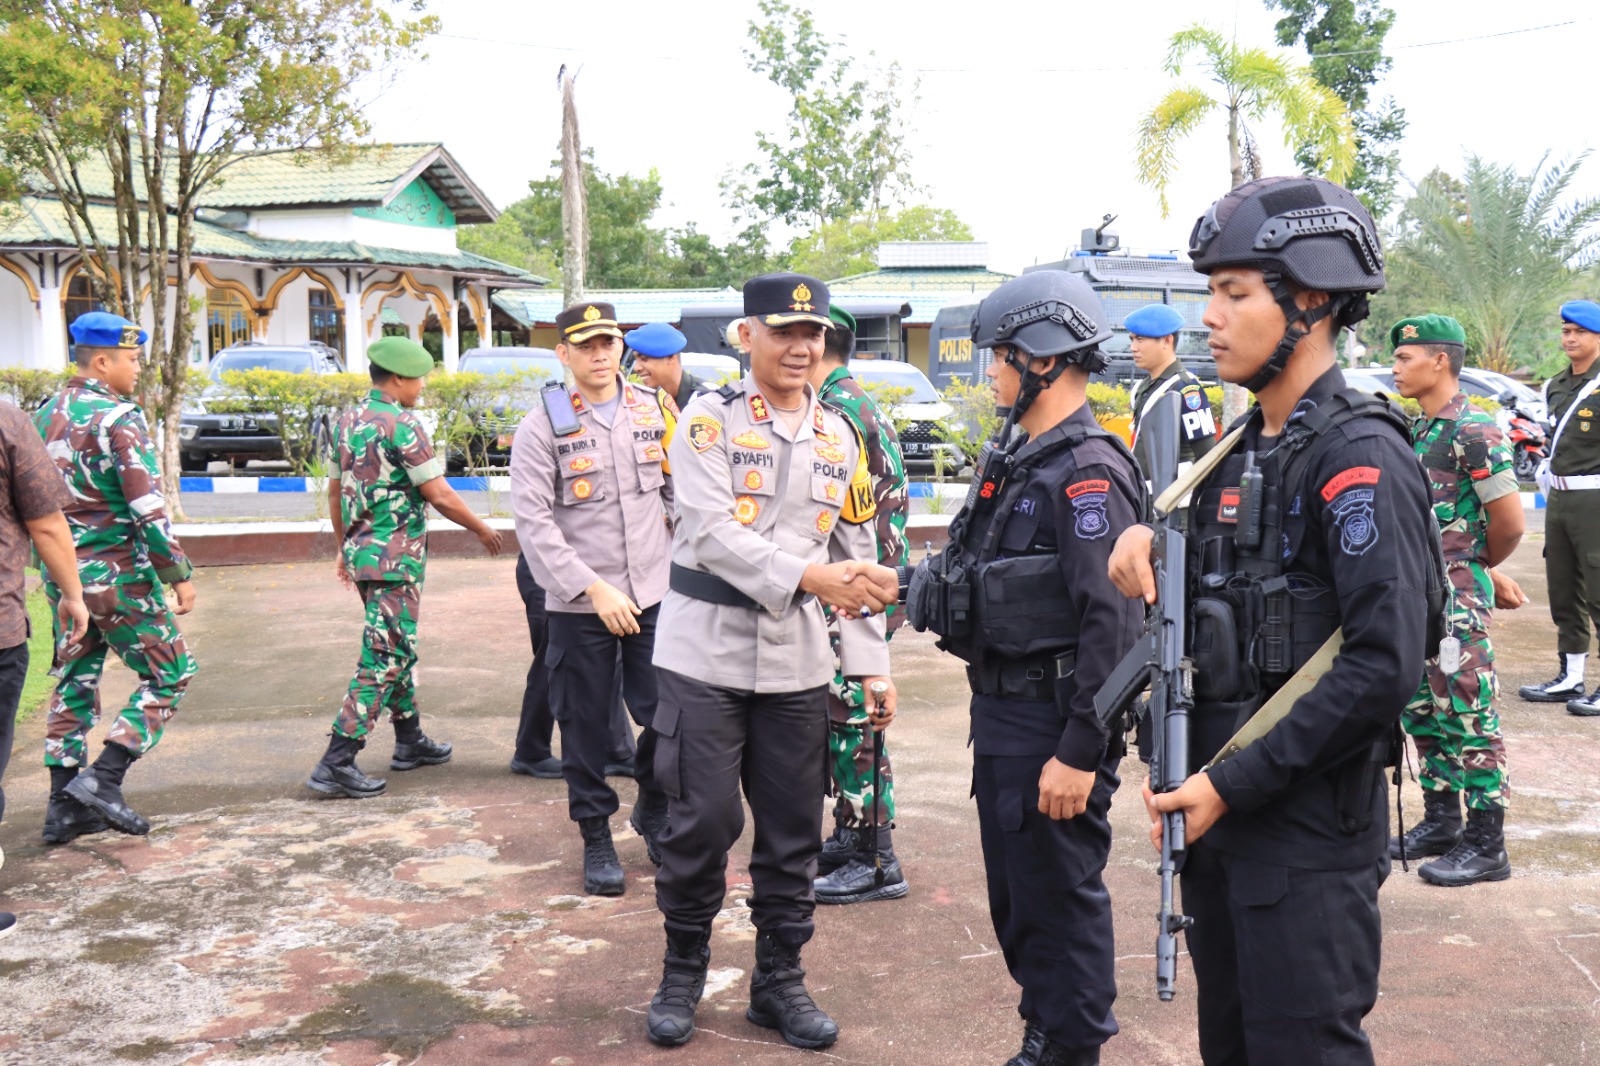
xmin=14 ymin=142 xmax=499 ymax=224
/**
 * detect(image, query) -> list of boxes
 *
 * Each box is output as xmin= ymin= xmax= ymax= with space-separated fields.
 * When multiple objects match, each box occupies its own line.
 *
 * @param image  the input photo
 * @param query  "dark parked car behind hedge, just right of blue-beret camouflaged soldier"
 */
xmin=178 ymin=343 xmax=344 ymax=474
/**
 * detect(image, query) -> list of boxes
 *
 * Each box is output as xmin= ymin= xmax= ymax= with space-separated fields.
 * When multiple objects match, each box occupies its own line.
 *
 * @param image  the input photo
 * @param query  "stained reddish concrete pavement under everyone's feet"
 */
xmin=0 ymin=539 xmax=1600 ymax=1066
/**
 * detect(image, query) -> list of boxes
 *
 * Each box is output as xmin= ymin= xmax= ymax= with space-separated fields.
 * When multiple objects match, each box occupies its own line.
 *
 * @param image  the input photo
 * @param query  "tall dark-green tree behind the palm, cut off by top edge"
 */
xmin=1266 ymin=0 xmax=1406 ymax=218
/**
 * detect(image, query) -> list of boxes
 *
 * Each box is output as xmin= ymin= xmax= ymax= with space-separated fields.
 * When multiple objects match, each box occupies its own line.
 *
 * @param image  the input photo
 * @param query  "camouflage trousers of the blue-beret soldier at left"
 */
xmin=45 ymin=581 xmax=195 ymax=767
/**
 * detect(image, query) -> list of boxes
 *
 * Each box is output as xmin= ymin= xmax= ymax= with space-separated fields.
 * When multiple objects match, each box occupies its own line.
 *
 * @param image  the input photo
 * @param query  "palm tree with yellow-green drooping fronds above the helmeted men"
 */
xmin=1138 ymin=26 xmax=1355 ymax=218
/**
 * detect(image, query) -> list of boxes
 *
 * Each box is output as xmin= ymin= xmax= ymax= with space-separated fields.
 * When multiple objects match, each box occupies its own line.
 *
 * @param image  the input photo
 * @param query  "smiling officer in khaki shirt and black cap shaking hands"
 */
xmin=648 ymin=274 xmax=898 ymax=1048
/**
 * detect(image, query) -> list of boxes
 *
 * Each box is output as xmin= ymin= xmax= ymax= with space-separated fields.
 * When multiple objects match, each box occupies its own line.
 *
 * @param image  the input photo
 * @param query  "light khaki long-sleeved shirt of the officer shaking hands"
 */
xmin=656 ymin=376 xmax=890 ymax=693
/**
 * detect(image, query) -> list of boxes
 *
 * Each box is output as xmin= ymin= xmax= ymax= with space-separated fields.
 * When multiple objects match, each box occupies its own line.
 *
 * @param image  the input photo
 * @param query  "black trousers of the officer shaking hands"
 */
xmin=656 ymin=671 xmax=827 ymax=935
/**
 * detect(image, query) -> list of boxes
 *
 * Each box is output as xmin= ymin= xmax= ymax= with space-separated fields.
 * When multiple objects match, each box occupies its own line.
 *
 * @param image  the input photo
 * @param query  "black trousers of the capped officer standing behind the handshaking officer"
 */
xmin=547 ymin=603 xmax=661 ymax=821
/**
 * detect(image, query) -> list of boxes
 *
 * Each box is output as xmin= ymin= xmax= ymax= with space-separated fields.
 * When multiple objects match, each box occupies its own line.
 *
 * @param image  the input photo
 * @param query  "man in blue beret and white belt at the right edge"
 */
xmin=1520 ymin=299 xmax=1600 ymax=717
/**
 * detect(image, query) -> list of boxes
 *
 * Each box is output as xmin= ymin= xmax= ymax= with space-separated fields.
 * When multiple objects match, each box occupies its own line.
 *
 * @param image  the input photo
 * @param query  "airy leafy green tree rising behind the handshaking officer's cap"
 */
xmin=723 ymin=0 xmax=915 ymax=240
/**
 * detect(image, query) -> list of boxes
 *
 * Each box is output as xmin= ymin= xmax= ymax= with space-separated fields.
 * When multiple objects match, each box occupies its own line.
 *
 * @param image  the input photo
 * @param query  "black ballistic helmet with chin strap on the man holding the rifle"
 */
xmin=1189 ymin=178 xmax=1384 ymax=392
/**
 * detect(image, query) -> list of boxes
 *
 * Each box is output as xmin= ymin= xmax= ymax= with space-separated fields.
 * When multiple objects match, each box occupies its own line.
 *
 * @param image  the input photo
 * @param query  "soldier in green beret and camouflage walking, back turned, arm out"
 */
xmin=306 ymin=336 xmax=501 ymax=799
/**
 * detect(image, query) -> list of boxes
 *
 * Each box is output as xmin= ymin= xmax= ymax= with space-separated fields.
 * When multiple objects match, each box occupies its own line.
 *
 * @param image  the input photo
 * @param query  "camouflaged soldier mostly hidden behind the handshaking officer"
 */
xmin=811 ymin=306 xmax=910 ymax=903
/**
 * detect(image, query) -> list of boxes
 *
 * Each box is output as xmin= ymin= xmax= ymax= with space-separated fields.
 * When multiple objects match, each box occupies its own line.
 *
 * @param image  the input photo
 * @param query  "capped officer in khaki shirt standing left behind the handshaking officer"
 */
xmin=510 ymin=303 xmax=672 ymax=896
